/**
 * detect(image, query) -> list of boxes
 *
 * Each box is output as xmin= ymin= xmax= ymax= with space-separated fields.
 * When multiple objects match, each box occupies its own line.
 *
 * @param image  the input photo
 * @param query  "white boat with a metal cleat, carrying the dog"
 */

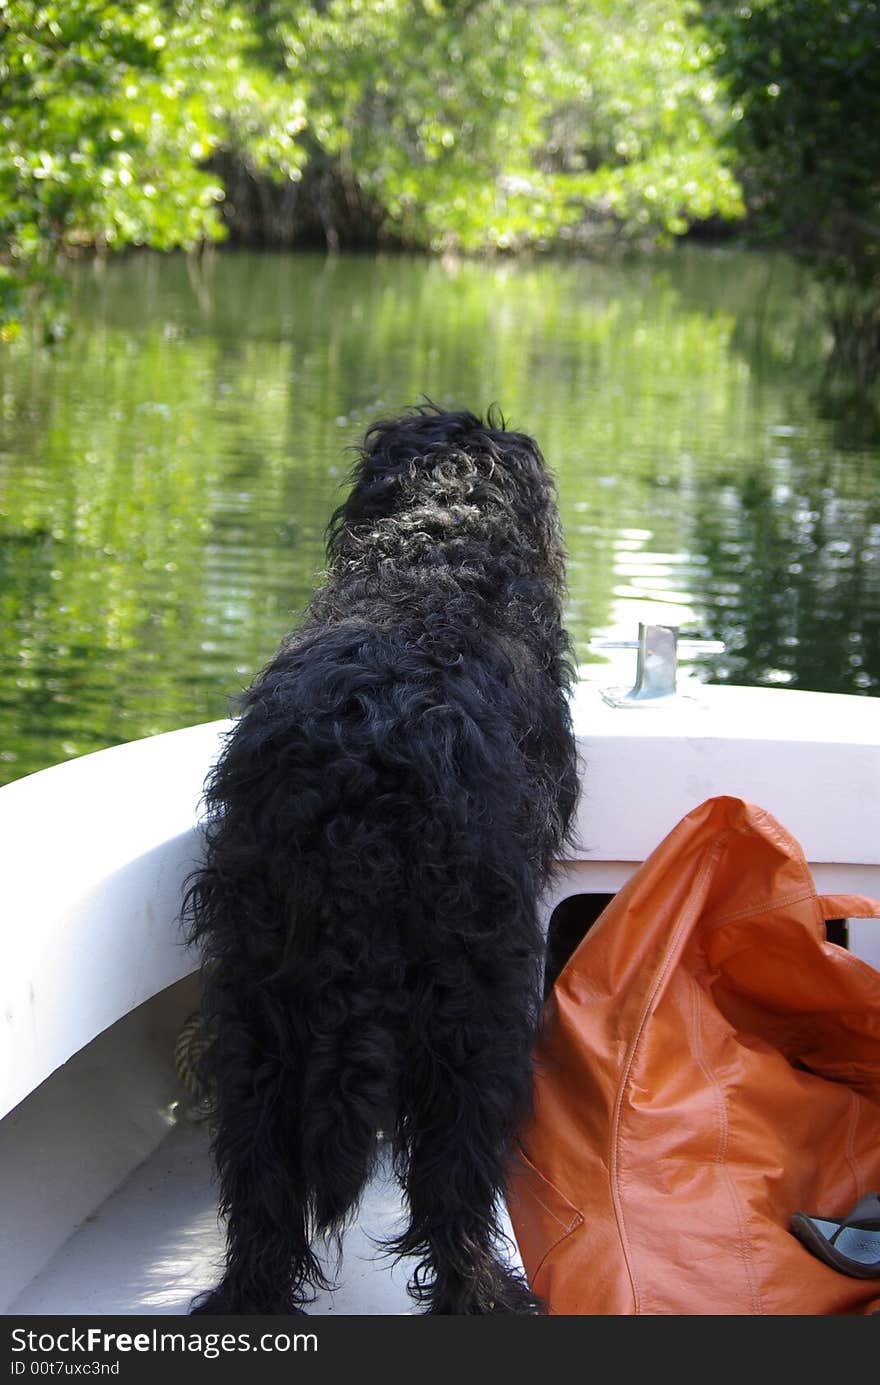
xmin=0 ymin=627 xmax=880 ymax=1316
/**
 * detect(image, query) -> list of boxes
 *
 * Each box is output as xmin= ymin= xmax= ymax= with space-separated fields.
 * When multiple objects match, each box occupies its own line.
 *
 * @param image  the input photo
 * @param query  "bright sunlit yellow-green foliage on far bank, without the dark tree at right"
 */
xmin=0 ymin=0 xmax=740 ymax=309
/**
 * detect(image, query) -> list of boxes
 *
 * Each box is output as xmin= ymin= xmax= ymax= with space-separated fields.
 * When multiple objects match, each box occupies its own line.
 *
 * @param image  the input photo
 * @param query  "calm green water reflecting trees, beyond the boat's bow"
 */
xmin=0 ymin=249 xmax=880 ymax=780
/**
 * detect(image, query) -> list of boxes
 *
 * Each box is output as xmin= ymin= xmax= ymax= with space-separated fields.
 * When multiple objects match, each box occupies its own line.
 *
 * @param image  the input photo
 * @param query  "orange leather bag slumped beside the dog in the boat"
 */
xmin=509 ymin=798 xmax=880 ymax=1314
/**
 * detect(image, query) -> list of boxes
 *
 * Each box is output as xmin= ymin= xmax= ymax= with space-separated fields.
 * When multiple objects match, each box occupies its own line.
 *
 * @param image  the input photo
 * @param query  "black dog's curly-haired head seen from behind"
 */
xmin=327 ymin=403 xmax=564 ymax=590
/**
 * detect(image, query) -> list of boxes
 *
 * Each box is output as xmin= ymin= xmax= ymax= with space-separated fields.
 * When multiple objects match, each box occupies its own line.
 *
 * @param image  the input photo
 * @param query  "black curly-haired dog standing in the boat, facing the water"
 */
xmin=186 ymin=404 xmax=577 ymax=1314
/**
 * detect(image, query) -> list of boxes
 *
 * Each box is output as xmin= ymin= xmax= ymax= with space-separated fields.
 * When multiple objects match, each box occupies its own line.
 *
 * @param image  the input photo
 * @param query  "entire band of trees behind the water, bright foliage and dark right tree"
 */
xmin=0 ymin=0 xmax=880 ymax=374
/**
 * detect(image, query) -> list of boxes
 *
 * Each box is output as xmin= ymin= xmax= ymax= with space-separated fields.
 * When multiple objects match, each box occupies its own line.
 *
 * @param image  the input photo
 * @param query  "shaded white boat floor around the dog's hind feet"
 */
xmin=0 ymin=975 xmax=521 ymax=1317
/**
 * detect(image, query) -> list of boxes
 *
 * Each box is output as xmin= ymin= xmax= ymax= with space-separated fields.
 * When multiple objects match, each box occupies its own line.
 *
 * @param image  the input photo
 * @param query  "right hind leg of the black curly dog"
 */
xmin=389 ymin=914 xmax=540 ymax=1314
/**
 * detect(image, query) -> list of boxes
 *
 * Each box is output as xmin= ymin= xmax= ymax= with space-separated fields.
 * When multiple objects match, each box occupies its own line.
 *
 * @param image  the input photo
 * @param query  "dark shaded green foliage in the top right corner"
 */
xmin=705 ymin=0 xmax=880 ymax=285
